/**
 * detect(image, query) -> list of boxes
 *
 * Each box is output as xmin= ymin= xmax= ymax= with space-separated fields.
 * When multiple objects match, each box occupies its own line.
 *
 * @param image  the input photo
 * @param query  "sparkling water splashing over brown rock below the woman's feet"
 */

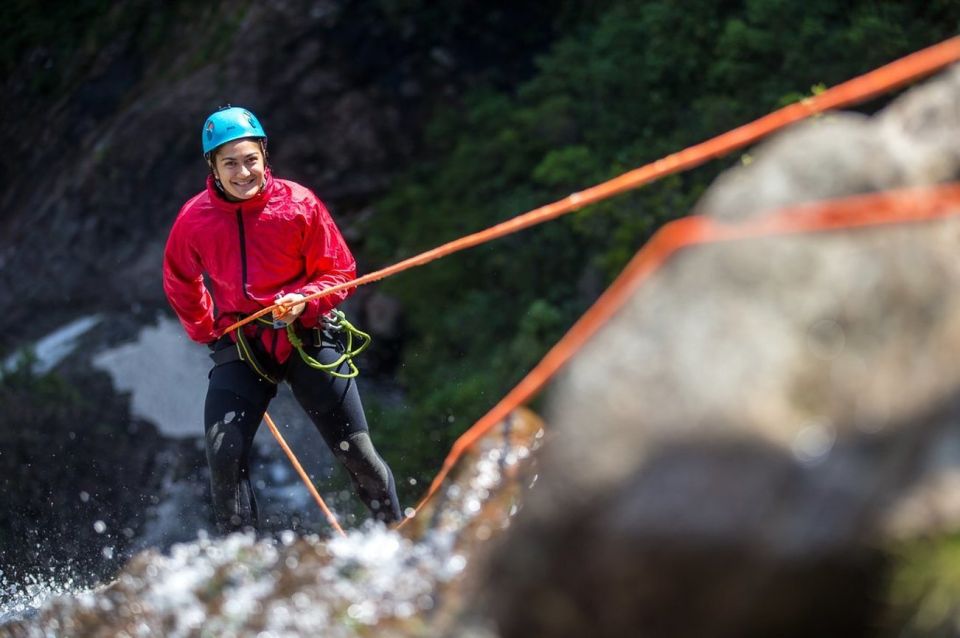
xmin=0 ymin=410 xmax=542 ymax=638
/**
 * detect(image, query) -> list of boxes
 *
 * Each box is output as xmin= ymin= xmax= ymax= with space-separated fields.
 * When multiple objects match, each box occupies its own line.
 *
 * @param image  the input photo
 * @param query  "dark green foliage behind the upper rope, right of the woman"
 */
xmin=368 ymin=0 xmax=960 ymax=488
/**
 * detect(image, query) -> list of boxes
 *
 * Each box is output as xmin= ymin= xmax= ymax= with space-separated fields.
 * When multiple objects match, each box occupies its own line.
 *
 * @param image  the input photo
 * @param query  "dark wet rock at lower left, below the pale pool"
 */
xmin=0 ymin=360 xmax=213 ymax=596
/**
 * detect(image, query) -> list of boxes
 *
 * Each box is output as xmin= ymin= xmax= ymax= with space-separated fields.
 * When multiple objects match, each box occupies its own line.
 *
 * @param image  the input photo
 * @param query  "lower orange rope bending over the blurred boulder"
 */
xmin=398 ymin=184 xmax=960 ymax=527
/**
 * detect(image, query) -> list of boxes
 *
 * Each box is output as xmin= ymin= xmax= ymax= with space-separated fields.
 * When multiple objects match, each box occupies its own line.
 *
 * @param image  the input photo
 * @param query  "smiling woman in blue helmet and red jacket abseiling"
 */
xmin=163 ymin=107 xmax=400 ymax=533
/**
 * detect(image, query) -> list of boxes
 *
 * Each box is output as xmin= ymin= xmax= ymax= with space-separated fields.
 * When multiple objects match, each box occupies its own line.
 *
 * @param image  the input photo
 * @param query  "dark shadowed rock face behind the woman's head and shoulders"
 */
xmin=0 ymin=0 xmax=568 ymax=351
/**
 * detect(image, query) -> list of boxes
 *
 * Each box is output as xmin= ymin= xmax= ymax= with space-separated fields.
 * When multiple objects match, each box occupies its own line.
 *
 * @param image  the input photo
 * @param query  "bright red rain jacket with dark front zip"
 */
xmin=163 ymin=171 xmax=356 ymax=362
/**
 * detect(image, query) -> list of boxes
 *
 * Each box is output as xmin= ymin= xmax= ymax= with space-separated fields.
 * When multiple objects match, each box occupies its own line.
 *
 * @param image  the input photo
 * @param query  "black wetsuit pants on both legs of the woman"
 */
xmin=204 ymin=338 xmax=401 ymax=533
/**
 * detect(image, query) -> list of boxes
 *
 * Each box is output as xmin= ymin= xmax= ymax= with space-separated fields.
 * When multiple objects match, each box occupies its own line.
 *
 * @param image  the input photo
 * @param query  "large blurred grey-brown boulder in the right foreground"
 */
xmin=484 ymin=69 xmax=960 ymax=638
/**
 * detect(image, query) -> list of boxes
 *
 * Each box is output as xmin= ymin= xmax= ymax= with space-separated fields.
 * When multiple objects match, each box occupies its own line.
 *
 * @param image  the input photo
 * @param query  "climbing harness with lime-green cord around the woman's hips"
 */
xmin=211 ymin=309 xmax=372 ymax=385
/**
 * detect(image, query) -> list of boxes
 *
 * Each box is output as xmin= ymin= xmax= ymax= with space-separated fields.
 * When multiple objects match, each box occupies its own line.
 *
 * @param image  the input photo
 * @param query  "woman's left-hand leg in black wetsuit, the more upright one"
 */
xmin=204 ymin=352 xmax=277 ymax=534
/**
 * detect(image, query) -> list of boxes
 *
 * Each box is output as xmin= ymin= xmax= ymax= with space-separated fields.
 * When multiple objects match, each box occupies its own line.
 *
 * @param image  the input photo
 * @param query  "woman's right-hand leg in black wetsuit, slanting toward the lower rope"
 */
xmin=287 ymin=339 xmax=401 ymax=523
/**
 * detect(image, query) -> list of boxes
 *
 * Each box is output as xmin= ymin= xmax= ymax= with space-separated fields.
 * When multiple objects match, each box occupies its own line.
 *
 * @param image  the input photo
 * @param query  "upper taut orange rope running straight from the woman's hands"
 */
xmin=224 ymin=36 xmax=960 ymax=333
